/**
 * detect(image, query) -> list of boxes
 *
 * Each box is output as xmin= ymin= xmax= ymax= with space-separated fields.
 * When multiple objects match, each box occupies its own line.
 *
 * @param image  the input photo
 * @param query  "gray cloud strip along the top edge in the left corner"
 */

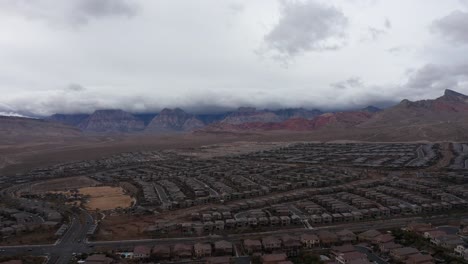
xmin=0 ymin=0 xmax=139 ymax=26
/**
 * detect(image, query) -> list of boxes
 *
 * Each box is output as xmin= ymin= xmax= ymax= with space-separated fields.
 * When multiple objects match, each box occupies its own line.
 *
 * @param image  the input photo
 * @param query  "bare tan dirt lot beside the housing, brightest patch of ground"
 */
xmin=78 ymin=186 xmax=135 ymax=211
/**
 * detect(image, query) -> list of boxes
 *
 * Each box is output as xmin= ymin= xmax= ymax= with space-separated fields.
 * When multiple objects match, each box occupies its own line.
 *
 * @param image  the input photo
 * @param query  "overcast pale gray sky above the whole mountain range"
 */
xmin=0 ymin=0 xmax=468 ymax=115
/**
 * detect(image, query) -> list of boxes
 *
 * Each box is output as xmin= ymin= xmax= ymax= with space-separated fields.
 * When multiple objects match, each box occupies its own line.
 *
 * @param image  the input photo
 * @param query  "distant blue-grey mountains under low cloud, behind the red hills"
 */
xmin=45 ymin=107 xmax=332 ymax=133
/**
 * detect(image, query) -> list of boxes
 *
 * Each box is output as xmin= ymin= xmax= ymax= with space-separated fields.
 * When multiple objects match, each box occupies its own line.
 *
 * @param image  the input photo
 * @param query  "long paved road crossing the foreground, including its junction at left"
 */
xmin=0 ymin=210 xmax=467 ymax=264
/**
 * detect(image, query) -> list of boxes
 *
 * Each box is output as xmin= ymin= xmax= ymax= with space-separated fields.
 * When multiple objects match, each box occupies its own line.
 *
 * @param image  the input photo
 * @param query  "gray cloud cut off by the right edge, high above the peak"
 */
xmin=431 ymin=10 xmax=468 ymax=44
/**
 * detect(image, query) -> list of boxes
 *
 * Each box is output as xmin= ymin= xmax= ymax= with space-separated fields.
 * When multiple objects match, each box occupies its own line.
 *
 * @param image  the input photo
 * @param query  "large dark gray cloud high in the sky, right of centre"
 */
xmin=264 ymin=1 xmax=348 ymax=58
